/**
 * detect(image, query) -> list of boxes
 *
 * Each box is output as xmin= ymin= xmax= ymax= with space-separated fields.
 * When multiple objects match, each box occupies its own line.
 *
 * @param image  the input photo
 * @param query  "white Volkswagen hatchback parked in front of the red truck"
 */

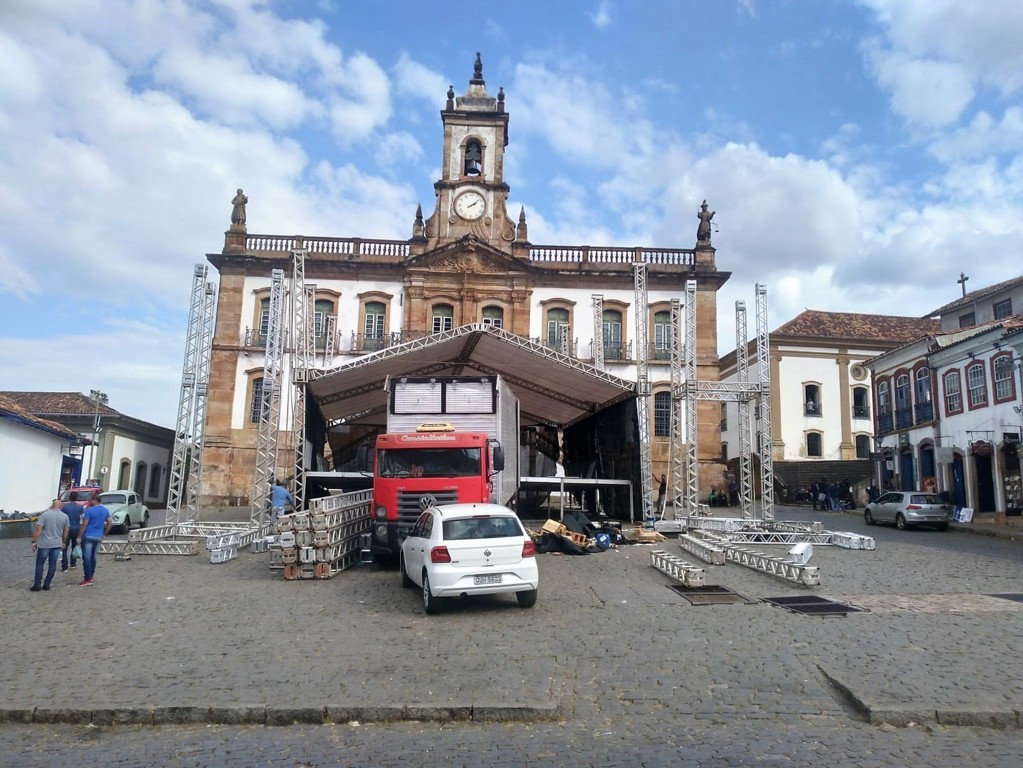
xmin=400 ymin=504 xmax=540 ymax=614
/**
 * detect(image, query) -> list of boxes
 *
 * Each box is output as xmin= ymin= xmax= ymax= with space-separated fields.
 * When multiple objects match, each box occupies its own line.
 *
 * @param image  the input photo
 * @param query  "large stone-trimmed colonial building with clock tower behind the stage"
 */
xmin=203 ymin=55 xmax=728 ymax=505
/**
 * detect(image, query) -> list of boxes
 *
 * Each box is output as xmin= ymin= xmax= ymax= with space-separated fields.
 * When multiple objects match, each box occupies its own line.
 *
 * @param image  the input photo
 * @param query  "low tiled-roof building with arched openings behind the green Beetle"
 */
xmin=0 ymin=392 xmax=174 ymax=508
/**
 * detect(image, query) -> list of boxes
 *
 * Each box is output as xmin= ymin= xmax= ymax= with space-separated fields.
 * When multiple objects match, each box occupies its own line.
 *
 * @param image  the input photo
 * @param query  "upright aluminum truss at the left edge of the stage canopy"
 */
xmin=291 ymin=250 xmax=316 ymax=509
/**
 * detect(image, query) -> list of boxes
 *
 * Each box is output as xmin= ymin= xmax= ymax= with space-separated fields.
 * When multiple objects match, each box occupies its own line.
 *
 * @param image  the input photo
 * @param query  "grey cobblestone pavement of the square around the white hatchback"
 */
xmin=0 ymin=509 xmax=1023 ymax=768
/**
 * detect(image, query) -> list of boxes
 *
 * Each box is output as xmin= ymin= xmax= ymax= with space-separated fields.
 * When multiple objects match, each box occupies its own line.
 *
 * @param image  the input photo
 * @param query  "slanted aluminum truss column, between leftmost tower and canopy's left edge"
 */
xmin=251 ymin=269 xmax=284 ymax=526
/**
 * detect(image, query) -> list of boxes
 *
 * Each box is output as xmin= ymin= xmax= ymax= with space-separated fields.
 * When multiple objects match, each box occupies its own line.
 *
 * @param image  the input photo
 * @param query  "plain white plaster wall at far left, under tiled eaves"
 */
xmin=0 ymin=418 xmax=68 ymax=513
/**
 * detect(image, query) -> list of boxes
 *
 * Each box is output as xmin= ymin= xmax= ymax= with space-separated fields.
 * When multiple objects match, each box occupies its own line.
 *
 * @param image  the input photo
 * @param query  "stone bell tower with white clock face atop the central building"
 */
xmin=426 ymin=53 xmax=515 ymax=254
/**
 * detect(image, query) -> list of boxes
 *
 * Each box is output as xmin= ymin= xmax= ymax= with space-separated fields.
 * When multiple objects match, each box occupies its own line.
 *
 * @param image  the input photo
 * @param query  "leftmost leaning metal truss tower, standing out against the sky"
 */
xmin=167 ymin=264 xmax=215 ymax=526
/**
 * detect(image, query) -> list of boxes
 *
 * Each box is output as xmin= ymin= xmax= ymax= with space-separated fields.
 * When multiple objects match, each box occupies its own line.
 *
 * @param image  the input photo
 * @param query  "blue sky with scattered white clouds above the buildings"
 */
xmin=0 ymin=0 xmax=1023 ymax=427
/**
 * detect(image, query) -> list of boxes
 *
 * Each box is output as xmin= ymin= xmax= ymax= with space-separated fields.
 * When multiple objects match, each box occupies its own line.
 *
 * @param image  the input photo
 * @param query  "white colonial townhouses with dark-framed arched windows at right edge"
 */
xmin=866 ymin=277 xmax=1023 ymax=514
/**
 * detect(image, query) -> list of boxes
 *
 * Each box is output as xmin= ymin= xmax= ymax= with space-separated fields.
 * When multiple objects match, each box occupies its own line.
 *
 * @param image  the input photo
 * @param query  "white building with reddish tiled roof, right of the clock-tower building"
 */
xmin=721 ymin=310 xmax=937 ymax=499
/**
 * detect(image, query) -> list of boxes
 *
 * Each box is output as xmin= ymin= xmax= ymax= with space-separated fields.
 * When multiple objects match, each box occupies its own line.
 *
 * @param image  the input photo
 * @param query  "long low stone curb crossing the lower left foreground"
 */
xmin=0 ymin=705 xmax=565 ymax=726
